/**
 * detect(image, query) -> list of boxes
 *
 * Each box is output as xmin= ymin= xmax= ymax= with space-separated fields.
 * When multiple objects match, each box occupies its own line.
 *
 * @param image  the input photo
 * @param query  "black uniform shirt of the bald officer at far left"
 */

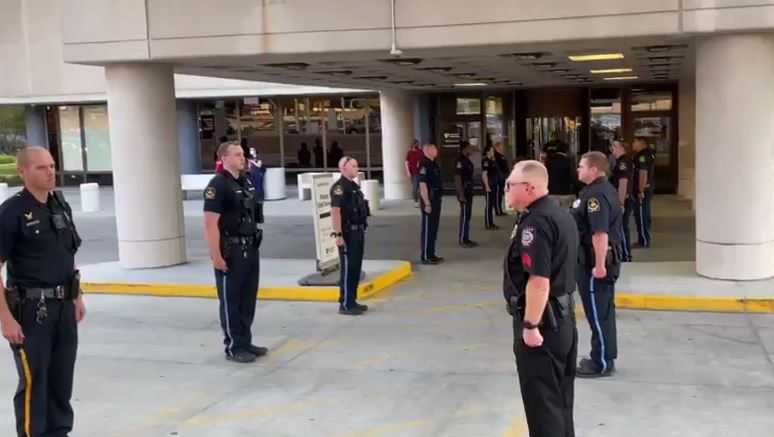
xmin=0 ymin=189 xmax=78 ymax=288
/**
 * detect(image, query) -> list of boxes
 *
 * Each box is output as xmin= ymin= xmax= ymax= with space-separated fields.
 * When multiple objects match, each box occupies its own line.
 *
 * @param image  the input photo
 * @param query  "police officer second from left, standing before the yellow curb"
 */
xmin=204 ymin=142 xmax=268 ymax=363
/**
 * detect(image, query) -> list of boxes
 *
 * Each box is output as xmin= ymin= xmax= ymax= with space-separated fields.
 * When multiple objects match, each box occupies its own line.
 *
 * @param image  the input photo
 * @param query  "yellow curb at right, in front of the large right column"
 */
xmin=615 ymin=292 xmax=774 ymax=313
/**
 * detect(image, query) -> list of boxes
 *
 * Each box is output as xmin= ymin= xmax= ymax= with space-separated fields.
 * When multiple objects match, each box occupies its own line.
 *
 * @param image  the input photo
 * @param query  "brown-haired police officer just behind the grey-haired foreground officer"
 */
xmin=572 ymin=152 xmax=623 ymax=378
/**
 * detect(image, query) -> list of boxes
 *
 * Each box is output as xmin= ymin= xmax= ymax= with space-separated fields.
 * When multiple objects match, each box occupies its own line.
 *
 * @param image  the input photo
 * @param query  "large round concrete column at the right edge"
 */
xmin=695 ymin=34 xmax=774 ymax=280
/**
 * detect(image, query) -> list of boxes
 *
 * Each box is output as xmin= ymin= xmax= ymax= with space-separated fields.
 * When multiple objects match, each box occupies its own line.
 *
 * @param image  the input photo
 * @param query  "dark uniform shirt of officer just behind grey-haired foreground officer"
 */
xmin=572 ymin=177 xmax=623 ymax=247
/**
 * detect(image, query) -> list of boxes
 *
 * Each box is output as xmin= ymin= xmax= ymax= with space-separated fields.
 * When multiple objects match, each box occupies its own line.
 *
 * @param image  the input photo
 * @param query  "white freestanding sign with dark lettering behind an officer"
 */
xmin=312 ymin=173 xmax=339 ymax=272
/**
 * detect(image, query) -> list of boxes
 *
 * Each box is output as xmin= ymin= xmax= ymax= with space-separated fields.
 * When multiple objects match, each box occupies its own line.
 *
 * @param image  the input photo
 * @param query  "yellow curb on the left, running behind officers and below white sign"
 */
xmin=81 ymin=261 xmax=412 ymax=302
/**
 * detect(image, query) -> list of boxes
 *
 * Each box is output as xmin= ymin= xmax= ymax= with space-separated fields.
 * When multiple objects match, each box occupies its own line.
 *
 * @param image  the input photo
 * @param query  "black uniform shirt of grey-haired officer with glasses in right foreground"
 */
xmin=503 ymin=196 xmax=578 ymax=301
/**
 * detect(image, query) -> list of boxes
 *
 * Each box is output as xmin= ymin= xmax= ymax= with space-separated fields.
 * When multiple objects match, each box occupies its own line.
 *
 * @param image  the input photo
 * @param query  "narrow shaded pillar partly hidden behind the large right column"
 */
xmin=677 ymin=74 xmax=696 ymax=204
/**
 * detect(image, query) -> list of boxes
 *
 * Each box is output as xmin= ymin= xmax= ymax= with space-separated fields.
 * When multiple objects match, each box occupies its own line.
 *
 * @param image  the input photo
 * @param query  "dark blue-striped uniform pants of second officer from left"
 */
xmin=215 ymin=245 xmax=260 ymax=355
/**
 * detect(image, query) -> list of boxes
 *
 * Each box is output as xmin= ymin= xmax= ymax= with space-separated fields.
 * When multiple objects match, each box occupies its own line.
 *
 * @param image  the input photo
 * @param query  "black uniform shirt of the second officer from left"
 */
xmin=204 ymin=170 xmax=258 ymax=236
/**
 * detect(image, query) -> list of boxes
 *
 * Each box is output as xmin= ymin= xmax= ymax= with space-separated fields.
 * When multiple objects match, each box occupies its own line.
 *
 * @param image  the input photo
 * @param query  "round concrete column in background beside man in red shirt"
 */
xmin=380 ymin=90 xmax=415 ymax=199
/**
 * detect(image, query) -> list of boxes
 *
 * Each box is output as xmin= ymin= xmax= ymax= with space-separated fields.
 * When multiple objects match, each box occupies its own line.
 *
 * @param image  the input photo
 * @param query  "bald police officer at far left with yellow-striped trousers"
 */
xmin=0 ymin=146 xmax=86 ymax=437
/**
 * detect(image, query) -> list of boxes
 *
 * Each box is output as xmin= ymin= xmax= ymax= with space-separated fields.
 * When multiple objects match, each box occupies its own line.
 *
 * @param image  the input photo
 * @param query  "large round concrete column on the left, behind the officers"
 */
xmin=105 ymin=64 xmax=186 ymax=268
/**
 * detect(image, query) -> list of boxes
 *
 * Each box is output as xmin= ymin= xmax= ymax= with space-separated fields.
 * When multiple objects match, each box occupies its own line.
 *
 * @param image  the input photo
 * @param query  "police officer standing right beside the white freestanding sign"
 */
xmin=330 ymin=156 xmax=369 ymax=316
